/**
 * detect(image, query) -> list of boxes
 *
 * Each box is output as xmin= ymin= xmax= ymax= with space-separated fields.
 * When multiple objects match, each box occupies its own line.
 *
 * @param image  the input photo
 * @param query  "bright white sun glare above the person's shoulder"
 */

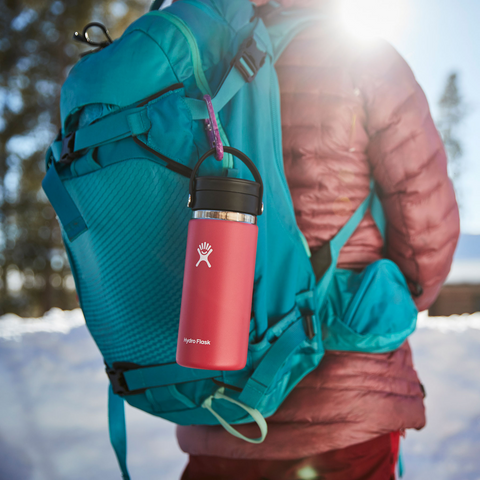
xmin=339 ymin=0 xmax=409 ymax=39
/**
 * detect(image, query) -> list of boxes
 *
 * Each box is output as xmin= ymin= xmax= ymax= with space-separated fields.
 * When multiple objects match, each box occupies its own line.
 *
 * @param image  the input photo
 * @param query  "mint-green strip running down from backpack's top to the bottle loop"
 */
xmin=151 ymin=12 xmax=233 ymax=169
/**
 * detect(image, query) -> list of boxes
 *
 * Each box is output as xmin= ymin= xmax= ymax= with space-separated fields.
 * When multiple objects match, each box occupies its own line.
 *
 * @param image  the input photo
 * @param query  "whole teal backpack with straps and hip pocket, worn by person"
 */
xmin=43 ymin=0 xmax=416 ymax=478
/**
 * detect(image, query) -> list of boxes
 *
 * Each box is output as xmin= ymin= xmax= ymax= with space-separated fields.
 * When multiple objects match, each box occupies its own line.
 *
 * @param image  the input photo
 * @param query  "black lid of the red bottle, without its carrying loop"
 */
xmin=192 ymin=177 xmax=260 ymax=215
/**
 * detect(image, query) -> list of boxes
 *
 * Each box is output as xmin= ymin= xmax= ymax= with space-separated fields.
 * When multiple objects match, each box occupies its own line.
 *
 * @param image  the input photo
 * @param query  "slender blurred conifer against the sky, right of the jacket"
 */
xmin=437 ymin=72 xmax=467 ymax=192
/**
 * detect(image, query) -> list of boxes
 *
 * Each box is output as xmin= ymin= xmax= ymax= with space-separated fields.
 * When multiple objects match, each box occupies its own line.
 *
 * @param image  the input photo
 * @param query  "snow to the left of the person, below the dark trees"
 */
xmin=0 ymin=310 xmax=187 ymax=480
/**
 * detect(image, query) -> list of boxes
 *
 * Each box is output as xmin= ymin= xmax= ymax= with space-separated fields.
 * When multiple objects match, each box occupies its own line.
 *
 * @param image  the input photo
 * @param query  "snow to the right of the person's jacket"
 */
xmin=404 ymin=313 xmax=480 ymax=480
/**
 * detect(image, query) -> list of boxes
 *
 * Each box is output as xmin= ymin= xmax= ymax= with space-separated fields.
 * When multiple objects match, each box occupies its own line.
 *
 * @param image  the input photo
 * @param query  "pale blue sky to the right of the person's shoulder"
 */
xmin=340 ymin=0 xmax=480 ymax=234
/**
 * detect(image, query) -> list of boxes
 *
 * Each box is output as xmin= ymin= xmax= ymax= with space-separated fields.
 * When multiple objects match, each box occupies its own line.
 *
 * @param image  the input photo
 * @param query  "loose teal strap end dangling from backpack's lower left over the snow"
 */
xmin=108 ymin=385 xmax=130 ymax=480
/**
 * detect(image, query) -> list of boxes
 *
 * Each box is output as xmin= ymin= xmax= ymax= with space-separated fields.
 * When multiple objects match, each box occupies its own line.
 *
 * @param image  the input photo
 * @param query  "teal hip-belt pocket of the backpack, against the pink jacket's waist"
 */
xmin=322 ymin=259 xmax=418 ymax=353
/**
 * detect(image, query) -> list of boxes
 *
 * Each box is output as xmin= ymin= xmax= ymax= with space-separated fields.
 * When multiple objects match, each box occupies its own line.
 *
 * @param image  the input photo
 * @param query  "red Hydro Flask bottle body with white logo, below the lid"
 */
xmin=177 ymin=217 xmax=258 ymax=370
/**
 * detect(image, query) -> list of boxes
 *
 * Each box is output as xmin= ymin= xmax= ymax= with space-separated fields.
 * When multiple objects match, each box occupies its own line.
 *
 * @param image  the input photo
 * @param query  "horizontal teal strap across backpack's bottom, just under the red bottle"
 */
xmin=123 ymin=363 xmax=221 ymax=391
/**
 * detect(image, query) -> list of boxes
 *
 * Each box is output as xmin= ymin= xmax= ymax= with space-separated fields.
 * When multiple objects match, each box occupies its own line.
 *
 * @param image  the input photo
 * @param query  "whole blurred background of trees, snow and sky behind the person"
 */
xmin=0 ymin=0 xmax=480 ymax=480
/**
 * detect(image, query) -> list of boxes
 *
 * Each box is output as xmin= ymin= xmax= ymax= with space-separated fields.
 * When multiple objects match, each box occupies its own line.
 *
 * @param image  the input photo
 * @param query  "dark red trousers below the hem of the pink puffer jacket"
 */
xmin=181 ymin=432 xmax=400 ymax=480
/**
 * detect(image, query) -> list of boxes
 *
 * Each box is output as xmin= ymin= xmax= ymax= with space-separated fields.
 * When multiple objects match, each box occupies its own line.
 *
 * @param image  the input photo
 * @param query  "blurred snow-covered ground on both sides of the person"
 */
xmin=0 ymin=310 xmax=480 ymax=480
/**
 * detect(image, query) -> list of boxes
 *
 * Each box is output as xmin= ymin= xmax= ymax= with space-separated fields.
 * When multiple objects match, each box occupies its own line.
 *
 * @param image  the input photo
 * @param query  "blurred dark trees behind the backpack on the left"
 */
xmin=0 ymin=0 xmax=149 ymax=316
